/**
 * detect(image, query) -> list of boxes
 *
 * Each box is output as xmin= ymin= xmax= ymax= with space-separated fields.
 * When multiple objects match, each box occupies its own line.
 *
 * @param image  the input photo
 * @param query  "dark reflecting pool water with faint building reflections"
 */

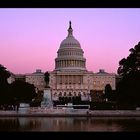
xmin=0 ymin=117 xmax=140 ymax=132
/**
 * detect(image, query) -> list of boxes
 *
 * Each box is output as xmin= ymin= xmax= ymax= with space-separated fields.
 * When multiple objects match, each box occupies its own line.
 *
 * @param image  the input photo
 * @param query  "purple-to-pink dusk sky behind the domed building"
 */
xmin=0 ymin=8 xmax=140 ymax=74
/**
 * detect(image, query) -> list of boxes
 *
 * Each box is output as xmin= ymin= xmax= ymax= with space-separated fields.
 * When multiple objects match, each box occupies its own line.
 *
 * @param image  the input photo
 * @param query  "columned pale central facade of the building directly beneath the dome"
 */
xmin=50 ymin=71 xmax=92 ymax=100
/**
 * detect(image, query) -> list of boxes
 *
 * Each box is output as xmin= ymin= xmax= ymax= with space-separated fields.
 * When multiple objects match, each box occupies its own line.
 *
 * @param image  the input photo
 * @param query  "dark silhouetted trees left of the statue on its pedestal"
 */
xmin=0 ymin=64 xmax=36 ymax=110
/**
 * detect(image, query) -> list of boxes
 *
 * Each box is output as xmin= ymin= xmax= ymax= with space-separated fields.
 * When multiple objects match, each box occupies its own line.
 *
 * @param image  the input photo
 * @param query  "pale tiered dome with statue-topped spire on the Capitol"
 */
xmin=55 ymin=22 xmax=86 ymax=71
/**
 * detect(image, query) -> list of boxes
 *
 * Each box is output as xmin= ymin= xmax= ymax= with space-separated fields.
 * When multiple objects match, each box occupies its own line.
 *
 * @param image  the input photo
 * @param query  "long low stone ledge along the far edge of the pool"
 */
xmin=0 ymin=108 xmax=140 ymax=117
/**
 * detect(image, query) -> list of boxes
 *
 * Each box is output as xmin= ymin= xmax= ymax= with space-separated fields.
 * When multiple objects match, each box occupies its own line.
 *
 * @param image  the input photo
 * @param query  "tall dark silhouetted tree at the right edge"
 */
xmin=117 ymin=42 xmax=140 ymax=107
